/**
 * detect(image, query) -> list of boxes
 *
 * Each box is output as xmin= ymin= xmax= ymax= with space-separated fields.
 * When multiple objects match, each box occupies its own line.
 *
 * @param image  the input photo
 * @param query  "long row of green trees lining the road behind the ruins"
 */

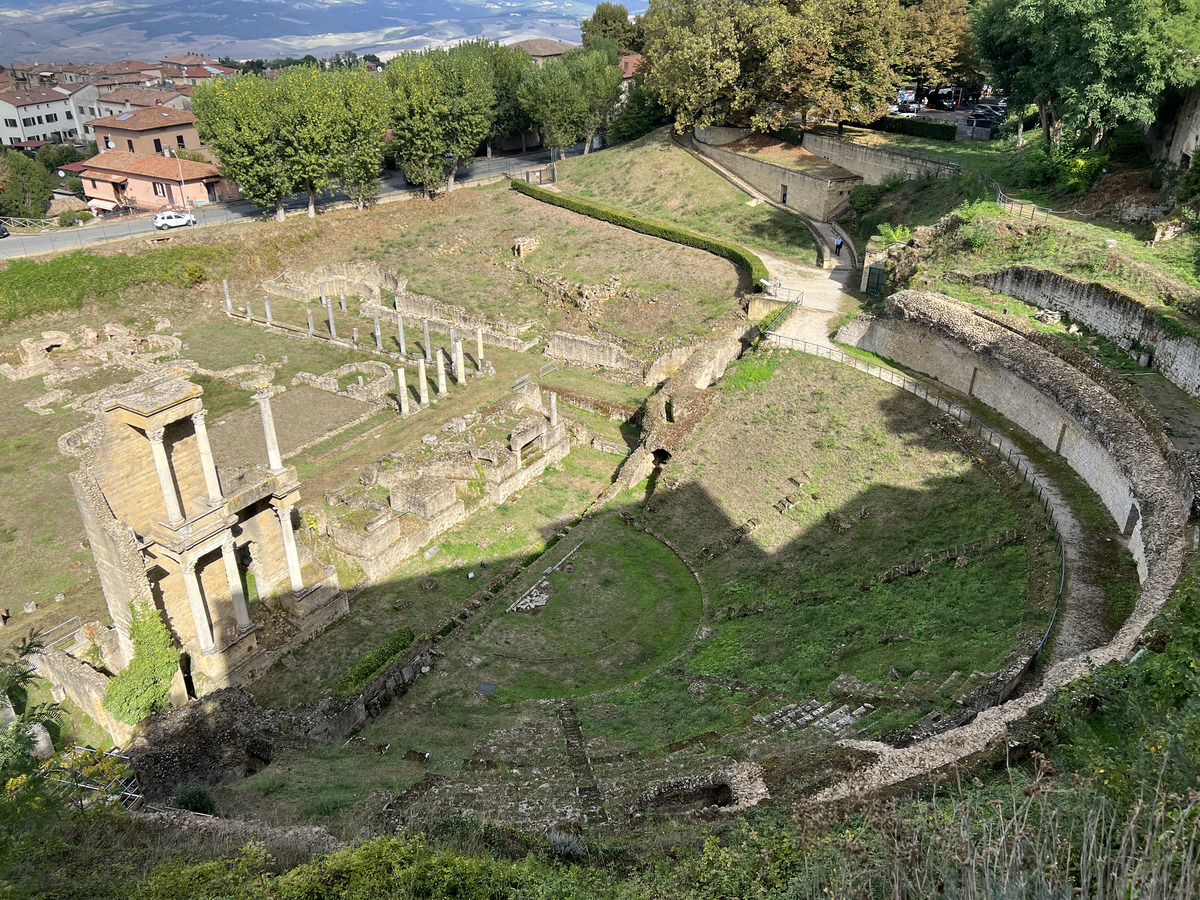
xmin=192 ymin=41 xmax=620 ymax=220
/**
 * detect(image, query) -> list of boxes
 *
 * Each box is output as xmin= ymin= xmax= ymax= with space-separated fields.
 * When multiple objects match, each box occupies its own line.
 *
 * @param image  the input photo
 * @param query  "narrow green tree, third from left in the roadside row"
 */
xmin=335 ymin=66 xmax=391 ymax=209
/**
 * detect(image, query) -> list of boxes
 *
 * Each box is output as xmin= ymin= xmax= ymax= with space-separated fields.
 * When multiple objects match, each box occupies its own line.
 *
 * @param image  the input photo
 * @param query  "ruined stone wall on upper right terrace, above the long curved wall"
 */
xmin=982 ymin=265 xmax=1200 ymax=397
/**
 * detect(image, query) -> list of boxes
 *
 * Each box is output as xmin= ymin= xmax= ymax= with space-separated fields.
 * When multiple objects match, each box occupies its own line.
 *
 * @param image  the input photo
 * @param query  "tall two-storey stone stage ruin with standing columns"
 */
xmin=59 ymin=370 xmax=347 ymax=737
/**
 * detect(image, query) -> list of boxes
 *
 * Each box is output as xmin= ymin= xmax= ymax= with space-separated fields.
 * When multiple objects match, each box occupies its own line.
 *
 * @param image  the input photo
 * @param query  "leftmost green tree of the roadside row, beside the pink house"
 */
xmin=192 ymin=74 xmax=298 ymax=222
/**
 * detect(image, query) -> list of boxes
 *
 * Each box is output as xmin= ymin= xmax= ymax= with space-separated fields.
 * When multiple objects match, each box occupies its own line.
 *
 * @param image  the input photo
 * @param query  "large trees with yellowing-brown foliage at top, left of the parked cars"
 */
xmin=638 ymin=0 xmax=979 ymax=130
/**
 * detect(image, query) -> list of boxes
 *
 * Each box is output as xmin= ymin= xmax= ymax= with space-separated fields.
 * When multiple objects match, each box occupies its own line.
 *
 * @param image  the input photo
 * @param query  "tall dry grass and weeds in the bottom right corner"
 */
xmin=781 ymin=776 xmax=1200 ymax=900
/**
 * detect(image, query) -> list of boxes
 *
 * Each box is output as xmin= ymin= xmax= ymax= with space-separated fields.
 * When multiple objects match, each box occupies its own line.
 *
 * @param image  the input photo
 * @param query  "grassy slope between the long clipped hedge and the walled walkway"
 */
xmin=558 ymin=128 xmax=816 ymax=265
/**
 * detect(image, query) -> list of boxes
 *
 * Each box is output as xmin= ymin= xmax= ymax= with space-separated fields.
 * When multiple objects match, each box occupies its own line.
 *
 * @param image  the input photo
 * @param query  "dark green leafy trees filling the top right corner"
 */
xmin=972 ymin=0 xmax=1200 ymax=149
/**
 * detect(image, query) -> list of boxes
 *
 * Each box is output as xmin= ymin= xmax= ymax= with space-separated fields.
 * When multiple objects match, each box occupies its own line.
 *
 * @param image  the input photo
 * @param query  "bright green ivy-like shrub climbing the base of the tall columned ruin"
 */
xmin=104 ymin=604 xmax=179 ymax=725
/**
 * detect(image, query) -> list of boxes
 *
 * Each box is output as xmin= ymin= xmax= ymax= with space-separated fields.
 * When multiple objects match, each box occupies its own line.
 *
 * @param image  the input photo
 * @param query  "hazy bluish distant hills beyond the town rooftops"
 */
xmin=0 ymin=0 xmax=646 ymax=65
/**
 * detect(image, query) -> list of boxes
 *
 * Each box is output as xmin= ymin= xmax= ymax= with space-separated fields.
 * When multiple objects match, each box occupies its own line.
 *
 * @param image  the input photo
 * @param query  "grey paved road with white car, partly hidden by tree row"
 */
xmin=0 ymin=145 xmax=559 ymax=259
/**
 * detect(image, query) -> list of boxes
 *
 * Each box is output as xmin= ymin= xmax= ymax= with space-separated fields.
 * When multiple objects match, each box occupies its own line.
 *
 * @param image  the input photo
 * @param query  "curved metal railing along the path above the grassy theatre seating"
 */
xmin=766 ymin=331 xmax=1067 ymax=668
